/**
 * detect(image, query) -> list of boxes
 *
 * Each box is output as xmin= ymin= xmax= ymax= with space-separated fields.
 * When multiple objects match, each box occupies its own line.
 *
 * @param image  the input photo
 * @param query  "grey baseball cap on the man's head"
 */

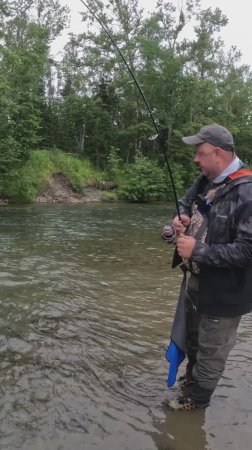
xmin=182 ymin=123 xmax=234 ymax=151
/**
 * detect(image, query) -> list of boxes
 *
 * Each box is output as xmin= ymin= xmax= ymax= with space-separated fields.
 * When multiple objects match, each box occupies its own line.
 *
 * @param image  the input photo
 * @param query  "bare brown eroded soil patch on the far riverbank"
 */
xmin=36 ymin=173 xmax=101 ymax=203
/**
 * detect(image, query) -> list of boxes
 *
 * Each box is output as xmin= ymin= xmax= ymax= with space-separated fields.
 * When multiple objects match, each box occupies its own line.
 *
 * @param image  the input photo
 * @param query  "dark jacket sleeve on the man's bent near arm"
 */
xmin=192 ymin=201 xmax=252 ymax=268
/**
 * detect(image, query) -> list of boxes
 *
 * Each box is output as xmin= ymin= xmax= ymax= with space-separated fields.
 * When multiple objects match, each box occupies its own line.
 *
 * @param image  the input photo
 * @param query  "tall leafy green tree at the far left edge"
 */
xmin=0 ymin=0 xmax=67 ymax=173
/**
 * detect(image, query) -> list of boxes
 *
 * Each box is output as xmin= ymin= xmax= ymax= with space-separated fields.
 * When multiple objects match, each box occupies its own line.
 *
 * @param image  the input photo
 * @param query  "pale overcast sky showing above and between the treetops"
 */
xmin=56 ymin=0 xmax=252 ymax=68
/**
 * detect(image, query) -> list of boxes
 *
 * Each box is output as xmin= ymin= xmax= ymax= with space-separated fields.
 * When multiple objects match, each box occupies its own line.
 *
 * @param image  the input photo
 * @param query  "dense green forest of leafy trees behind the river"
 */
xmin=0 ymin=0 xmax=252 ymax=200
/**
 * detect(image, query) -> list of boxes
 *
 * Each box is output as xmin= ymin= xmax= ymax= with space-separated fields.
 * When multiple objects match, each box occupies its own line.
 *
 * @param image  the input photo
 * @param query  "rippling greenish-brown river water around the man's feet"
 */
xmin=0 ymin=204 xmax=252 ymax=450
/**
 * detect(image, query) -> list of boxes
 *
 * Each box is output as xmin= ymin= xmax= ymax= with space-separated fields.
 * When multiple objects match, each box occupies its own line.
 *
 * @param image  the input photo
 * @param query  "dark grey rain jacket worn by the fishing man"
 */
xmin=177 ymin=171 xmax=252 ymax=317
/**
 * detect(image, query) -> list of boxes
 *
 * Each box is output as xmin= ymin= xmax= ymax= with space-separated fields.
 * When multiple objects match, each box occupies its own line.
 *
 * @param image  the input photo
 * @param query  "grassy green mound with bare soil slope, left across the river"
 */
xmin=0 ymin=150 xmax=111 ymax=205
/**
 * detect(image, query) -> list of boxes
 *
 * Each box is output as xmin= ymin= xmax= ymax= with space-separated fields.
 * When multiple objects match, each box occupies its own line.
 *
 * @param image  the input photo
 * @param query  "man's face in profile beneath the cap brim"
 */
xmin=194 ymin=142 xmax=220 ymax=180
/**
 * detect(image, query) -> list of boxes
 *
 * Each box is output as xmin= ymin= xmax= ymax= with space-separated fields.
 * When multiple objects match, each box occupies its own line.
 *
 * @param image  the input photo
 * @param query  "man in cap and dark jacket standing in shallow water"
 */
xmin=169 ymin=124 xmax=252 ymax=410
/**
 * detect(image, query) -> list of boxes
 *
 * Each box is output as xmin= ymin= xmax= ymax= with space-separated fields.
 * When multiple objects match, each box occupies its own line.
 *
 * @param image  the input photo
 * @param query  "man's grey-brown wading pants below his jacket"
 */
xmin=186 ymin=275 xmax=241 ymax=404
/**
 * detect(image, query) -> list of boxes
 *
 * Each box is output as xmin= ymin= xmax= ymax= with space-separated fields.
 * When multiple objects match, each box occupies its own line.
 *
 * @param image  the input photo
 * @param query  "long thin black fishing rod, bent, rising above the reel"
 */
xmin=80 ymin=0 xmax=181 ymax=221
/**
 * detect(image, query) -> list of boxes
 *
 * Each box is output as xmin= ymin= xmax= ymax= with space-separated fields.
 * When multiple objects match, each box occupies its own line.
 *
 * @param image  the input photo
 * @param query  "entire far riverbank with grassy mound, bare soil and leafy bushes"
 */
xmin=0 ymin=149 xmax=168 ymax=205
